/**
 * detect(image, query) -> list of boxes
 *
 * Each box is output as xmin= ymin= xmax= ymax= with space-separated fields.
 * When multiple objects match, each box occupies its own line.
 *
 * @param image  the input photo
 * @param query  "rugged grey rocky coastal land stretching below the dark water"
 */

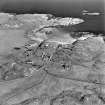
xmin=0 ymin=14 xmax=105 ymax=105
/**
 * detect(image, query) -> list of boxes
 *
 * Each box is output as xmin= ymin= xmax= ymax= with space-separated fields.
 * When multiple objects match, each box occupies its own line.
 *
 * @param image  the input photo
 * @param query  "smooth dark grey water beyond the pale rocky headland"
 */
xmin=0 ymin=0 xmax=105 ymax=34
